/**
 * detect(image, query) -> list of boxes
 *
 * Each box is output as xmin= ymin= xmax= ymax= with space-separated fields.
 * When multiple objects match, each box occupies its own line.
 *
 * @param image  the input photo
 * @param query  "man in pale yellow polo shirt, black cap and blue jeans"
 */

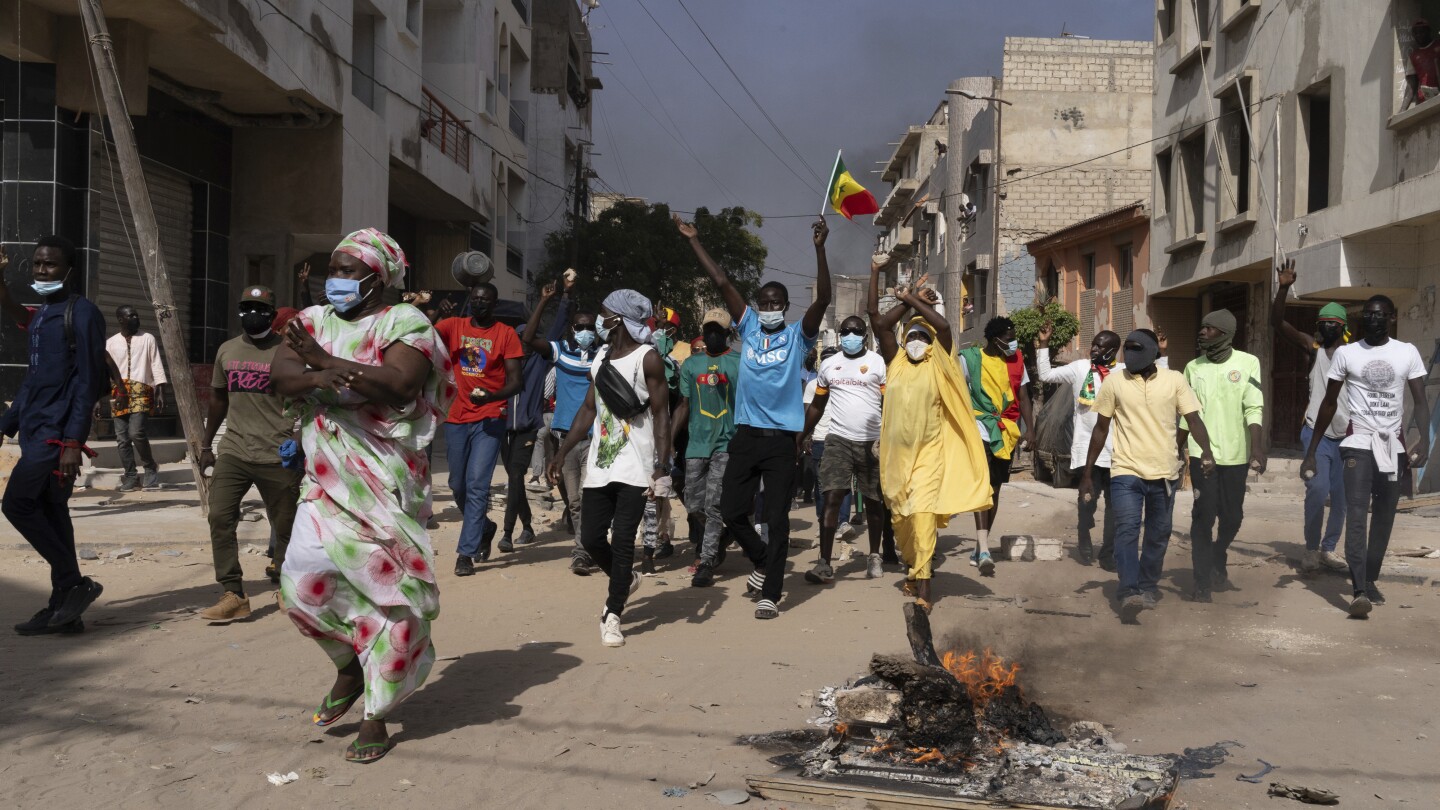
xmin=1080 ymin=329 xmax=1215 ymax=623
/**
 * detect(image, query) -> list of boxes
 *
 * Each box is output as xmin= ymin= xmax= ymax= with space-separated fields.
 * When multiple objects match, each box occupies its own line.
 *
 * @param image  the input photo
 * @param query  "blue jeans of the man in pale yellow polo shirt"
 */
xmin=1106 ymin=476 xmax=1175 ymax=600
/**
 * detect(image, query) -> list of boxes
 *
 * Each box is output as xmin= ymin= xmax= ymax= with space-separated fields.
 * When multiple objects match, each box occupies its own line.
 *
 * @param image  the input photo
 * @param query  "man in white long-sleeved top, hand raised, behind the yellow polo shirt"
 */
xmin=1035 ymin=323 xmax=1169 ymax=571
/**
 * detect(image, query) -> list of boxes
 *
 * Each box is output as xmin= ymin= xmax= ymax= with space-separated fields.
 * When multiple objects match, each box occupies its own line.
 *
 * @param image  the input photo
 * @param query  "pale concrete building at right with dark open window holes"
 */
xmin=1146 ymin=0 xmax=1440 ymax=466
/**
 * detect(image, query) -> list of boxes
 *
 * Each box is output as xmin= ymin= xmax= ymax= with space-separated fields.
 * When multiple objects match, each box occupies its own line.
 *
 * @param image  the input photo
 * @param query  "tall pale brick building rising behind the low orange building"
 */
xmin=932 ymin=37 xmax=1153 ymax=343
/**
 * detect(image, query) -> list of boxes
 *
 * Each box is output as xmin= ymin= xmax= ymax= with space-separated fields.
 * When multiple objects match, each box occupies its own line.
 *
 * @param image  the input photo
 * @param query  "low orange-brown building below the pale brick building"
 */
xmin=1025 ymin=202 xmax=1157 ymax=354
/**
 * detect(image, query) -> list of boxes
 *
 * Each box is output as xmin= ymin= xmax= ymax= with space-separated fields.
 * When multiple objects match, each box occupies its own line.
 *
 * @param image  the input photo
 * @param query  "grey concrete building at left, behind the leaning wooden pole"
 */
xmin=0 ymin=0 xmax=593 ymax=423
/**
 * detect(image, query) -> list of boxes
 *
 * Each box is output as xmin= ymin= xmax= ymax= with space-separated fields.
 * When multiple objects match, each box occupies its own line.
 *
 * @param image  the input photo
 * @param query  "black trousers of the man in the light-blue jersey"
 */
xmin=720 ymin=425 xmax=796 ymax=602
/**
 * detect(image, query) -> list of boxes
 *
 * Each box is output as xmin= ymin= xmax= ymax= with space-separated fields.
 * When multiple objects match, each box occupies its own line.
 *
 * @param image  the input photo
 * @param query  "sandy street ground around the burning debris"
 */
xmin=0 ymin=469 xmax=1440 ymax=809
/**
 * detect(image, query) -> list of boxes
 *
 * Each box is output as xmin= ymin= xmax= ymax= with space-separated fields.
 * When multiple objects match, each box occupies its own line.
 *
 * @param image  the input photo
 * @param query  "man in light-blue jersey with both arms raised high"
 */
xmin=675 ymin=216 xmax=831 ymax=618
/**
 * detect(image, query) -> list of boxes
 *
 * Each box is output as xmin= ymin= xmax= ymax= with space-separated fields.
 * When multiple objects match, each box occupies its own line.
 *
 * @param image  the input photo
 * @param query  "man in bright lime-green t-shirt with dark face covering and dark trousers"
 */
xmin=1181 ymin=310 xmax=1266 ymax=602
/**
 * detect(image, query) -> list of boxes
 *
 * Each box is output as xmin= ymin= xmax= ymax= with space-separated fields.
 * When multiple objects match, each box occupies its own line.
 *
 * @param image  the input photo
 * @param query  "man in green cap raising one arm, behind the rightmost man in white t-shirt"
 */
xmin=1270 ymin=259 xmax=1349 ymax=572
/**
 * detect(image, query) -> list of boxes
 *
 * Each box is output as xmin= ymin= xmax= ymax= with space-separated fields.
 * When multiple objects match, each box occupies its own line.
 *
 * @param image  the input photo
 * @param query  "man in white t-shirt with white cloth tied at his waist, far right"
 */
xmin=1300 ymin=295 xmax=1430 ymax=618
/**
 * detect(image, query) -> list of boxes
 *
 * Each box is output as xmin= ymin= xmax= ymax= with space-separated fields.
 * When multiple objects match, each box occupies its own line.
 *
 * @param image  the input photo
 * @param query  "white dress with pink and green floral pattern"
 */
xmin=281 ymin=304 xmax=455 ymax=719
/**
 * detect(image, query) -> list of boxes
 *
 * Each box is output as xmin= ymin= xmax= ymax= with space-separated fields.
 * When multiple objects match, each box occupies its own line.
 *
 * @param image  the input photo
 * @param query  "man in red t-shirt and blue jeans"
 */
xmin=435 ymin=282 xmax=524 ymax=577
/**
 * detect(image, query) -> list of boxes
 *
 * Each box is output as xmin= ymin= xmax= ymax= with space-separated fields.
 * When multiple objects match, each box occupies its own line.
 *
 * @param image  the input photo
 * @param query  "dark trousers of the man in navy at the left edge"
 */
xmin=0 ymin=441 xmax=82 ymax=610
